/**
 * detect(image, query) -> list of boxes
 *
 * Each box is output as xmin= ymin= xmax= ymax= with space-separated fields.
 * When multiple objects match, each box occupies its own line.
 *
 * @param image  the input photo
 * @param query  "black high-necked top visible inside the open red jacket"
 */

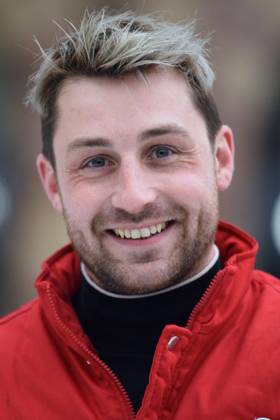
xmin=73 ymin=260 xmax=220 ymax=411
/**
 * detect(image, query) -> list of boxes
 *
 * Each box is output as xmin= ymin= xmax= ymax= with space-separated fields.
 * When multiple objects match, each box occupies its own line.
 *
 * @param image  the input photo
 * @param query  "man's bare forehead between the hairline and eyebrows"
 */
xmin=55 ymin=69 xmax=206 ymax=146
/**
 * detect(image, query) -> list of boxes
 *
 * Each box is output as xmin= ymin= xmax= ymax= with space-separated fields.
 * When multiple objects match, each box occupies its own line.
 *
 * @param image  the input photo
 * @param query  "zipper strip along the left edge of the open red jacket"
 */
xmin=47 ymin=284 xmax=136 ymax=419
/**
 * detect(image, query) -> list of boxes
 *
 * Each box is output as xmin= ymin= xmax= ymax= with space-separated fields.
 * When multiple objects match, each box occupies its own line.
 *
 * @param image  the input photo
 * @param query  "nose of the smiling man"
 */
xmin=112 ymin=161 xmax=160 ymax=214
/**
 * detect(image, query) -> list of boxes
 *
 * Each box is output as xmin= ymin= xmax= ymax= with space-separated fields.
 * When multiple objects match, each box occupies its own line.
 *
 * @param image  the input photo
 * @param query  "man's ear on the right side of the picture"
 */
xmin=214 ymin=125 xmax=234 ymax=191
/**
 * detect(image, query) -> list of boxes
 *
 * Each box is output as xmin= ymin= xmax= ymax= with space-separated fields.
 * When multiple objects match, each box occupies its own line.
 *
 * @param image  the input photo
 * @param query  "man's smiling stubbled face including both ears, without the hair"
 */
xmin=38 ymin=70 xmax=232 ymax=294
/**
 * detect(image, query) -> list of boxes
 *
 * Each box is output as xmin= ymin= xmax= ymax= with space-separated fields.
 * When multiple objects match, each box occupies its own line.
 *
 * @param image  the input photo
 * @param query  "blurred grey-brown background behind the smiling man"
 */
xmin=0 ymin=0 xmax=280 ymax=315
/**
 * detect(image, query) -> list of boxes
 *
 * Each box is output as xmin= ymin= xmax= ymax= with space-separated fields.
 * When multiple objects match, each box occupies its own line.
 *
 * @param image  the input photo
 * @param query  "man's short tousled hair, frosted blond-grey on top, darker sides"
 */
xmin=27 ymin=8 xmax=221 ymax=167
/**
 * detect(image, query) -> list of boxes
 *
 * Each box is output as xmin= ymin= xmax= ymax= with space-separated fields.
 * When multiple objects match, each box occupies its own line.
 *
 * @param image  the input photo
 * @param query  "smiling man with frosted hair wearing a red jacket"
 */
xmin=0 ymin=10 xmax=280 ymax=420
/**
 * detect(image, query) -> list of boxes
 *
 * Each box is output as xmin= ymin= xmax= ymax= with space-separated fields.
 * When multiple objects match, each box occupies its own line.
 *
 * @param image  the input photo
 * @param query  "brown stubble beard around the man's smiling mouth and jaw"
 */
xmin=64 ymin=192 xmax=218 ymax=295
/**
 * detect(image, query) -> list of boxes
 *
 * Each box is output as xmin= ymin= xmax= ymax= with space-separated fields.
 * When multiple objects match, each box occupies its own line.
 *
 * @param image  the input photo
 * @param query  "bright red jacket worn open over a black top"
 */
xmin=0 ymin=223 xmax=280 ymax=420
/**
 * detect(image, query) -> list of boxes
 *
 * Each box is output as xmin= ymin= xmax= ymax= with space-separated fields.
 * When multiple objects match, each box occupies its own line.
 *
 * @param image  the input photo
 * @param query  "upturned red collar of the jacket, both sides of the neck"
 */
xmin=35 ymin=221 xmax=258 ymax=344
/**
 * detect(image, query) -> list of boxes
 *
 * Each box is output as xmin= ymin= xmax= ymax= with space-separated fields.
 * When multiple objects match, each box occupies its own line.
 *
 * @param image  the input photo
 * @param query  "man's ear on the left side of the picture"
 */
xmin=36 ymin=153 xmax=63 ymax=213
